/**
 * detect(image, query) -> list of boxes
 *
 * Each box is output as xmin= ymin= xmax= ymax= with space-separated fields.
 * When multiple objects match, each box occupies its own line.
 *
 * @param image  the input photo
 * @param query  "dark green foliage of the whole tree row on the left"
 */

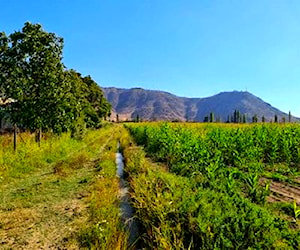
xmin=0 ymin=22 xmax=111 ymax=133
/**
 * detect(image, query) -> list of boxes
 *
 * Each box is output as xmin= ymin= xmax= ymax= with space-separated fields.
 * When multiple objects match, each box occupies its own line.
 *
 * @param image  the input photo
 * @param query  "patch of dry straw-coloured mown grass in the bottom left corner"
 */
xmin=0 ymin=199 xmax=87 ymax=249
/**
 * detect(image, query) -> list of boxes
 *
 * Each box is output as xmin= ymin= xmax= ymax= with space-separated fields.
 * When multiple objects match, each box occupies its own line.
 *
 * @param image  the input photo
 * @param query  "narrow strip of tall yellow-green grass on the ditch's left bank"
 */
xmin=78 ymin=131 xmax=128 ymax=249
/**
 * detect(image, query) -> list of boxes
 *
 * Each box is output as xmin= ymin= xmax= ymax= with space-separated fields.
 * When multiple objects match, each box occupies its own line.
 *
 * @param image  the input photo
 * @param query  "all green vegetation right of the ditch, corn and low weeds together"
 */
xmin=125 ymin=124 xmax=300 ymax=249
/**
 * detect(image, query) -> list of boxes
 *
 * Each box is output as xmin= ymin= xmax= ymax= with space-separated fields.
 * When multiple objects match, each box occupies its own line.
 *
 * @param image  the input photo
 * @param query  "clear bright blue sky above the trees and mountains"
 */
xmin=0 ymin=0 xmax=300 ymax=117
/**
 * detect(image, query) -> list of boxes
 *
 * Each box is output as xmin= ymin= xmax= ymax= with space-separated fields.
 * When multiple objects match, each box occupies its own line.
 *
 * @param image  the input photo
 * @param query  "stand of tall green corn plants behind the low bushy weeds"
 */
xmin=128 ymin=124 xmax=300 ymax=207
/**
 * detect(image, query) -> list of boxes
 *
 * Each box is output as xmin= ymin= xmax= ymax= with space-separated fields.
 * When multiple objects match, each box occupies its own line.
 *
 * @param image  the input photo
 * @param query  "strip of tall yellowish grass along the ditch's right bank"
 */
xmin=121 ymin=128 xmax=189 ymax=249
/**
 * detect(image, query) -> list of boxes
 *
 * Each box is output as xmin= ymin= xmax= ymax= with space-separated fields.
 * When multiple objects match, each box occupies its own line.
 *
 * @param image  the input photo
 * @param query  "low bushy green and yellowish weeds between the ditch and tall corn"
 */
xmin=120 ymin=128 xmax=300 ymax=249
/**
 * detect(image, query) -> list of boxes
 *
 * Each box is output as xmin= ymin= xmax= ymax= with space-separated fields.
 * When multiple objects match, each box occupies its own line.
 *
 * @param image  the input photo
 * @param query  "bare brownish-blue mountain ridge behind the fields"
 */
xmin=103 ymin=88 xmax=297 ymax=122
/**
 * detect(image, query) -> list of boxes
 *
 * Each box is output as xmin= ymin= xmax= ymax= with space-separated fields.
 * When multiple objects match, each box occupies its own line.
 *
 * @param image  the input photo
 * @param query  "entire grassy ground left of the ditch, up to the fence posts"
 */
xmin=0 ymin=126 xmax=127 ymax=249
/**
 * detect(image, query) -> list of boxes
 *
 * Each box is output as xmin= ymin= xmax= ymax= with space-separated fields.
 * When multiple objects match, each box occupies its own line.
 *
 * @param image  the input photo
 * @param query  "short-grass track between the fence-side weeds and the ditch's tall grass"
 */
xmin=0 ymin=130 xmax=111 ymax=250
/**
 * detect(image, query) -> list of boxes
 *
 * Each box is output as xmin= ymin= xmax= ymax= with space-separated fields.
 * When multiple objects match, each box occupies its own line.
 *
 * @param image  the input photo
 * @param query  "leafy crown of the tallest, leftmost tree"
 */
xmin=0 ymin=22 xmax=68 ymax=131
